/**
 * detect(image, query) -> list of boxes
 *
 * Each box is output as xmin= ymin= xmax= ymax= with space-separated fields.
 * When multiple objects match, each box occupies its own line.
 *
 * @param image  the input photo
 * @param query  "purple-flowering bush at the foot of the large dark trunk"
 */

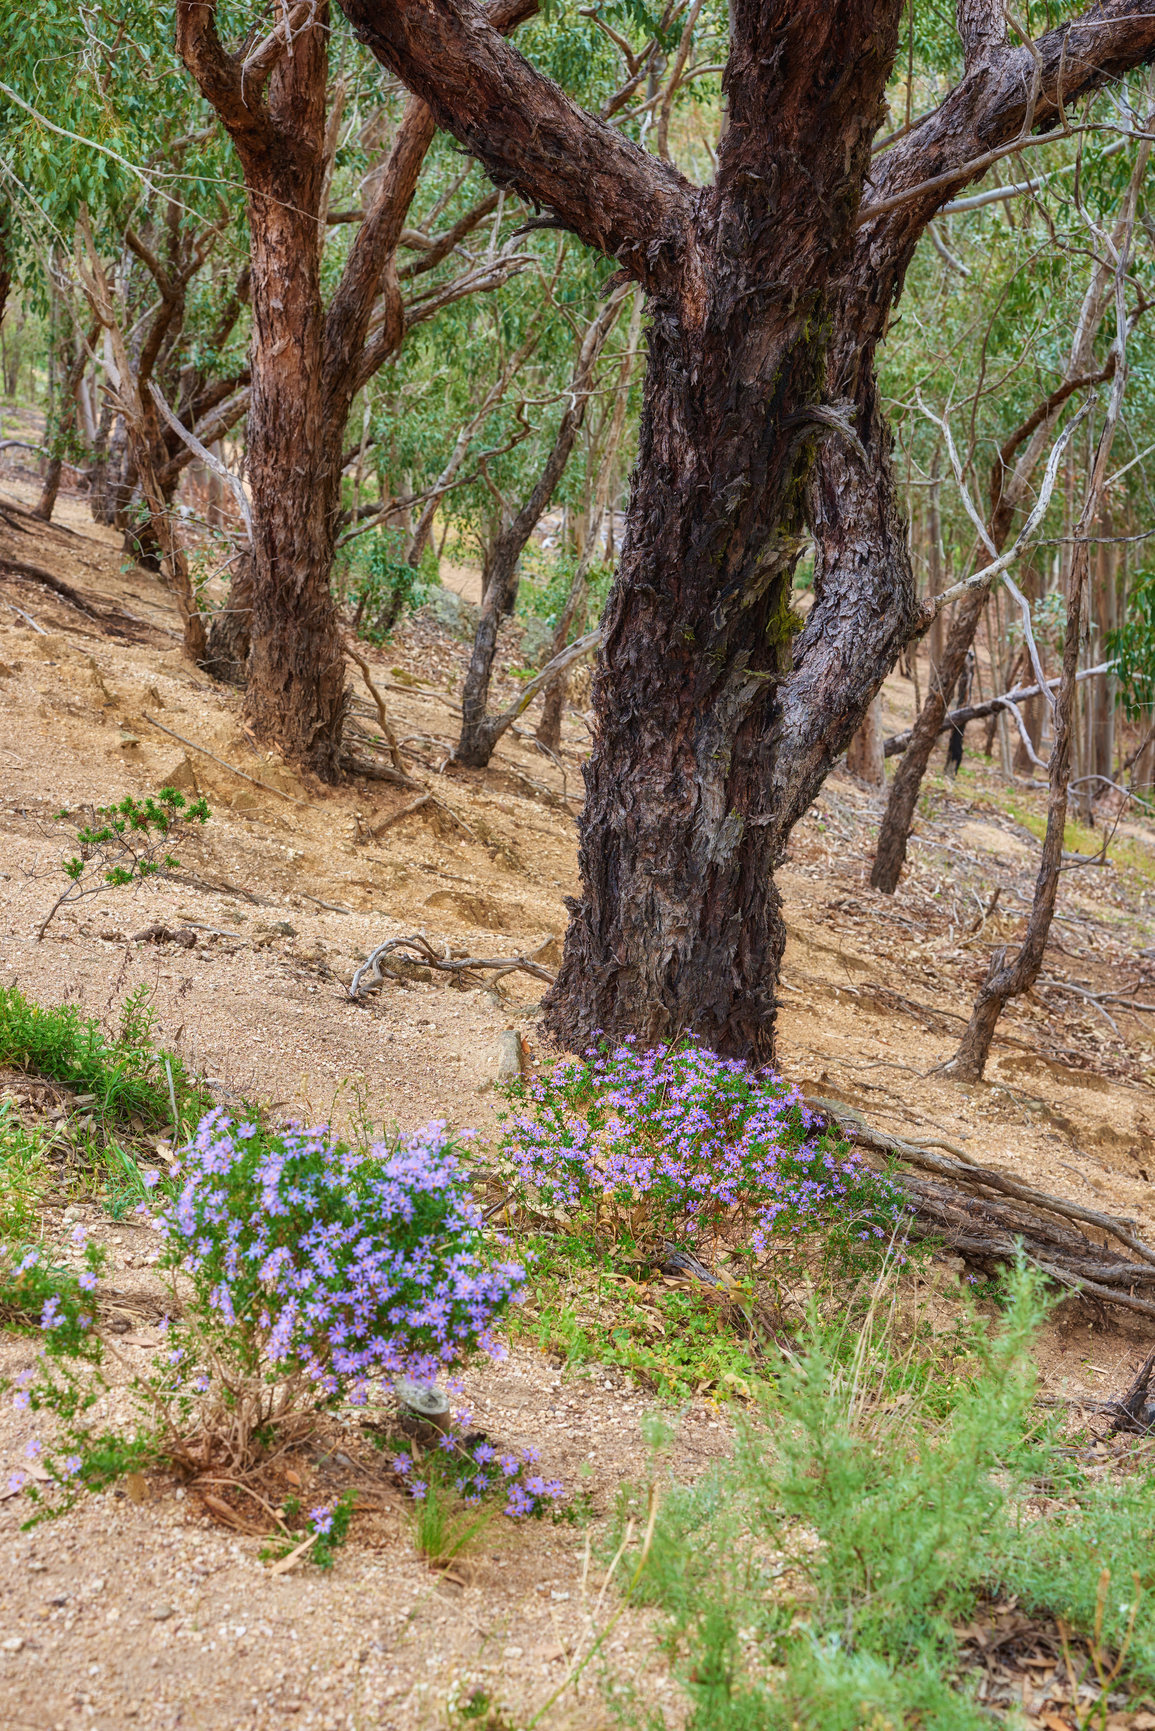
xmin=504 ymin=1039 xmax=900 ymax=1265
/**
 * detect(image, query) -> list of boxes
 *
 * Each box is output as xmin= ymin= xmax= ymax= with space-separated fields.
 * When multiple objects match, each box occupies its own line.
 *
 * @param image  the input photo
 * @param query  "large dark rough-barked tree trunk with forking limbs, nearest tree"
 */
xmin=335 ymin=0 xmax=1155 ymax=1059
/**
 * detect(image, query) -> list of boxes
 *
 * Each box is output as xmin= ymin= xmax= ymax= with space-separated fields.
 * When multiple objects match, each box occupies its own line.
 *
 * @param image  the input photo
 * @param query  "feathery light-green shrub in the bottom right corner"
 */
xmin=622 ymin=1269 xmax=1155 ymax=1731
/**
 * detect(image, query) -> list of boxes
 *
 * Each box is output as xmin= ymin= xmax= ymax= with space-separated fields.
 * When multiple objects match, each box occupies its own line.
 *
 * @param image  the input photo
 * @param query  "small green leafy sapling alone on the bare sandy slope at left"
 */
xmin=36 ymin=788 xmax=211 ymax=938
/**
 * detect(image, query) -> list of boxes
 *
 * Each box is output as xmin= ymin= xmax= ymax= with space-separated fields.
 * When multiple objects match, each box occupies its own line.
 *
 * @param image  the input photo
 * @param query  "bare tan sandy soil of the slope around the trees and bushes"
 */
xmin=0 ymin=460 xmax=1155 ymax=1731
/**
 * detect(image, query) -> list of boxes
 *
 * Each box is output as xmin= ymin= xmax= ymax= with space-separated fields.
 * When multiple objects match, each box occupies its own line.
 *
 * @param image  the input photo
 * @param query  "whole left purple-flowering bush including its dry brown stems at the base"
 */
xmin=9 ymin=1110 xmax=525 ymax=1502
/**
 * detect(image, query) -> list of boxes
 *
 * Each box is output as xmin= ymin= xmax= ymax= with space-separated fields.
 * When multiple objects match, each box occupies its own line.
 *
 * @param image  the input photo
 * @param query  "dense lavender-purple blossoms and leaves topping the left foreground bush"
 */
xmin=161 ymin=1110 xmax=525 ymax=1402
